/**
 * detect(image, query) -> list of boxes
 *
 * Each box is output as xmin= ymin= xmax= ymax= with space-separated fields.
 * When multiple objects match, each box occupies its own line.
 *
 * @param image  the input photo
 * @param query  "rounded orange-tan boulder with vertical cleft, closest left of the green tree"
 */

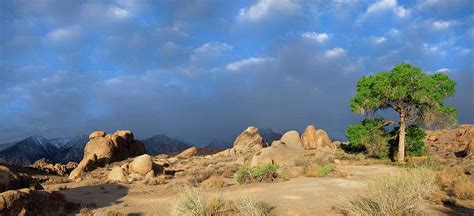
xmin=301 ymin=125 xmax=336 ymax=150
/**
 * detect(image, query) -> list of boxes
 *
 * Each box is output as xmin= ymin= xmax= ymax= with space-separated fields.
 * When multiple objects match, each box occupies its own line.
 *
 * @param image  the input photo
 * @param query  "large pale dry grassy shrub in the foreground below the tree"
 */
xmin=342 ymin=169 xmax=436 ymax=215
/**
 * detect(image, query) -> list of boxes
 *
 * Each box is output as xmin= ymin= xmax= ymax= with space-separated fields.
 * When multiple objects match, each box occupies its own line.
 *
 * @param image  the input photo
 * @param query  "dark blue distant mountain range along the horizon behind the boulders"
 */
xmin=0 ymin=129 xmax=281 ymax=165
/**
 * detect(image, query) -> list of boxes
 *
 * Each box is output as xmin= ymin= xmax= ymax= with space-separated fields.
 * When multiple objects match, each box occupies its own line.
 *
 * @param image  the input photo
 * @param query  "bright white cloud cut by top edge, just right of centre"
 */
xmin=237 ymin=0 xmax=301 ymax=22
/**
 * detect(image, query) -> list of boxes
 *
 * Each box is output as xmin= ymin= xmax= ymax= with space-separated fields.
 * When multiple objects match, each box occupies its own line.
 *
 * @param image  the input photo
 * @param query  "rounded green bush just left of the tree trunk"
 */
xmin=346 ymin=118 xmax=390 ymax=158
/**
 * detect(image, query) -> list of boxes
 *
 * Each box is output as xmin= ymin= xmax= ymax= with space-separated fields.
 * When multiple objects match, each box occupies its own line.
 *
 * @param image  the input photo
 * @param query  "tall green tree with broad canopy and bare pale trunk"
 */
xmin=350 ymin=64 xmax=457 ymax=162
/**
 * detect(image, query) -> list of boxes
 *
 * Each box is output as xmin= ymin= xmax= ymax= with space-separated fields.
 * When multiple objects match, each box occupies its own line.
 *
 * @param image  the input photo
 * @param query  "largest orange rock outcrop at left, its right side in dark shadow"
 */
xmin=69 ymin=130 xmax=145 ymax=180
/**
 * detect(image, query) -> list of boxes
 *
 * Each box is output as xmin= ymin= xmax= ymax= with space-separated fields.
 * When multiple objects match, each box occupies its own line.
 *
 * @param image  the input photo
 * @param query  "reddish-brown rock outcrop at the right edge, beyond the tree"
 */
xmin=425 ymin=125 xmax=474 ymax=158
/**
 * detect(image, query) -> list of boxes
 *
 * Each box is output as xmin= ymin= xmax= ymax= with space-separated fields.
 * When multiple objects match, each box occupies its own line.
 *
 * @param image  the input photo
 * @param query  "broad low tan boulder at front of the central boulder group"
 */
xmin=250 ymin=141 xmax=304 ymax=167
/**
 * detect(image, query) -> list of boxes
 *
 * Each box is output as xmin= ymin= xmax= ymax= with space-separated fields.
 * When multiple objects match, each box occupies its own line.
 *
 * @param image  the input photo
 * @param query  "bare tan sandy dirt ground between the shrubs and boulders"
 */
xmin=51 ymin=165 xmax=398 ymax=215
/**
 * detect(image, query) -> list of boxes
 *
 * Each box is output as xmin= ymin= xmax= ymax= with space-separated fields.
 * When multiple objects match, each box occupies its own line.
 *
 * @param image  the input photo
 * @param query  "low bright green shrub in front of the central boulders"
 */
xmin=235 ymin=163 xmax=279 ymax=184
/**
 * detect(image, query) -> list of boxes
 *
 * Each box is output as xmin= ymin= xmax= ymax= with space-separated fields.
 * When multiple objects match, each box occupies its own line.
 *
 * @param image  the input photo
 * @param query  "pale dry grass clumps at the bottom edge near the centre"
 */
xmin=173 ymin=188 xmax=271 ymax=216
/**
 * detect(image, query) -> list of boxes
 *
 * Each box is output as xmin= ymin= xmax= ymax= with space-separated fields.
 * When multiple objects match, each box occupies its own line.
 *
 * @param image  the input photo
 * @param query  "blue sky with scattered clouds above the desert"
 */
xmin=0 ymin=0 xmax=474 ymax=145
